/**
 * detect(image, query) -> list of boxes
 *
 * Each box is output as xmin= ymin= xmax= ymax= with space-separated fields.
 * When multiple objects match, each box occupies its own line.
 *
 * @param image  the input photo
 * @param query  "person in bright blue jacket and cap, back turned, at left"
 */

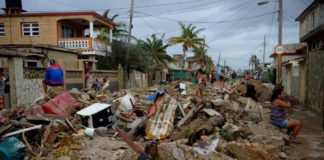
xmin=43 ymin=59 xmax=64 ymax=94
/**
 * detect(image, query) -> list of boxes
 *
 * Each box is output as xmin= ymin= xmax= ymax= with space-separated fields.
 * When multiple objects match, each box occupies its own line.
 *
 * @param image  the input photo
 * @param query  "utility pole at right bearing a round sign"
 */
xmin=277 ymin=0 xmax=283 ymax=84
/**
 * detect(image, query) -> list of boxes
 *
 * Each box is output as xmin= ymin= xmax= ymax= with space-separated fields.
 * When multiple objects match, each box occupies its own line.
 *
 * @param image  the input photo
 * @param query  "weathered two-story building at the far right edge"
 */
xmin=296 ymin=0 xmax=324 ymax=113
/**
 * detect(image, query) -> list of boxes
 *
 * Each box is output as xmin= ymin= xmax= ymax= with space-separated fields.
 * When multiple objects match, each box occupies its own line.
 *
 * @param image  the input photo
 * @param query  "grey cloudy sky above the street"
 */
xmin=0 ymin=0 xmax=313 ymax=69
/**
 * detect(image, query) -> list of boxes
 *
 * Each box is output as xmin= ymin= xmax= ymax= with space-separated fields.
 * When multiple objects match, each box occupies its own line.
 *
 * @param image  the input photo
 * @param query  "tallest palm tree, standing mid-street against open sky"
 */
xmin=170 ymin=22 xmax=206 ymax=79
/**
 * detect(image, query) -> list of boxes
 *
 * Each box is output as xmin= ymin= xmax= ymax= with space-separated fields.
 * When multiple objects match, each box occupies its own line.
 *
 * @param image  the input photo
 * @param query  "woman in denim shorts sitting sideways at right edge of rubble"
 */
xmin=270 ymin=86 xmax=301 ymax=143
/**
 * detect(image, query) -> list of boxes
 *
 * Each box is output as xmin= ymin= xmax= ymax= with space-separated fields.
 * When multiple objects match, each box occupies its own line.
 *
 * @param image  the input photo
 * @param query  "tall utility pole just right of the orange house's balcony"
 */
xmin=124 ymin=0 xmax=134 ymax=86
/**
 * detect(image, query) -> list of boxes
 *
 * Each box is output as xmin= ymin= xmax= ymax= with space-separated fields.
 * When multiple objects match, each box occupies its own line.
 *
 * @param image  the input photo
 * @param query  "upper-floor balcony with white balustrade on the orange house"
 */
xmin=57 ymin=17 xmax=112 ymax=56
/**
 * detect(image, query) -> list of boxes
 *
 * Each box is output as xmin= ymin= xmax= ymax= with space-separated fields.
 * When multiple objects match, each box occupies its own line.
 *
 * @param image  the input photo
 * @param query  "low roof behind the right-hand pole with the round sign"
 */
xmin=270 ymin=43 xmax=307 ymax=57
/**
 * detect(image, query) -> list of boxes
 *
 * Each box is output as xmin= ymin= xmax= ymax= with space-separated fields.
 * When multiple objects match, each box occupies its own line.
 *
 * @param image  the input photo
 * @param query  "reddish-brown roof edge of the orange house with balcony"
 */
xmin=0 ymin=11 xmax=115 ymax=26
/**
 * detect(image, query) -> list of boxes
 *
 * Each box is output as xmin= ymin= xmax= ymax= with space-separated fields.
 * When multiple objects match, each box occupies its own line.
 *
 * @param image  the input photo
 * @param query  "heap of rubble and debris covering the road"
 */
xmin=0 ymin=81 xmax=294 ymax=160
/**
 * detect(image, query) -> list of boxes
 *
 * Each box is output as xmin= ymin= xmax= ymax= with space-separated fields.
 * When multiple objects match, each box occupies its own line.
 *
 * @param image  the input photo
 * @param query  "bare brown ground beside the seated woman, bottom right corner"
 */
xmin=288 ymin=105 xmax=324 ymax=159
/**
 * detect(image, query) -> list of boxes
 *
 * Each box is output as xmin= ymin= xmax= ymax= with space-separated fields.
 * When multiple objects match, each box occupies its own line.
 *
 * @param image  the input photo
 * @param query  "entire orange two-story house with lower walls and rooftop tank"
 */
xmin=0 ymin=0 xmax=121 ymax=107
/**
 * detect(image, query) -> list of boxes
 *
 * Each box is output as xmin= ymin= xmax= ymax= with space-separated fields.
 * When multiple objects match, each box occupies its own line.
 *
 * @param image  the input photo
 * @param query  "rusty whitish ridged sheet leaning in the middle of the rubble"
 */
xmin=145 ymin=94 xmax=177 ymax=139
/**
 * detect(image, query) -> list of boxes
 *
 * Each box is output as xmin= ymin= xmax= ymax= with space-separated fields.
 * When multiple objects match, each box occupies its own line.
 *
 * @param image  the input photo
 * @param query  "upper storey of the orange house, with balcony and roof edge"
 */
xmin=0 ymin=11 xmax=114 ymax=69
